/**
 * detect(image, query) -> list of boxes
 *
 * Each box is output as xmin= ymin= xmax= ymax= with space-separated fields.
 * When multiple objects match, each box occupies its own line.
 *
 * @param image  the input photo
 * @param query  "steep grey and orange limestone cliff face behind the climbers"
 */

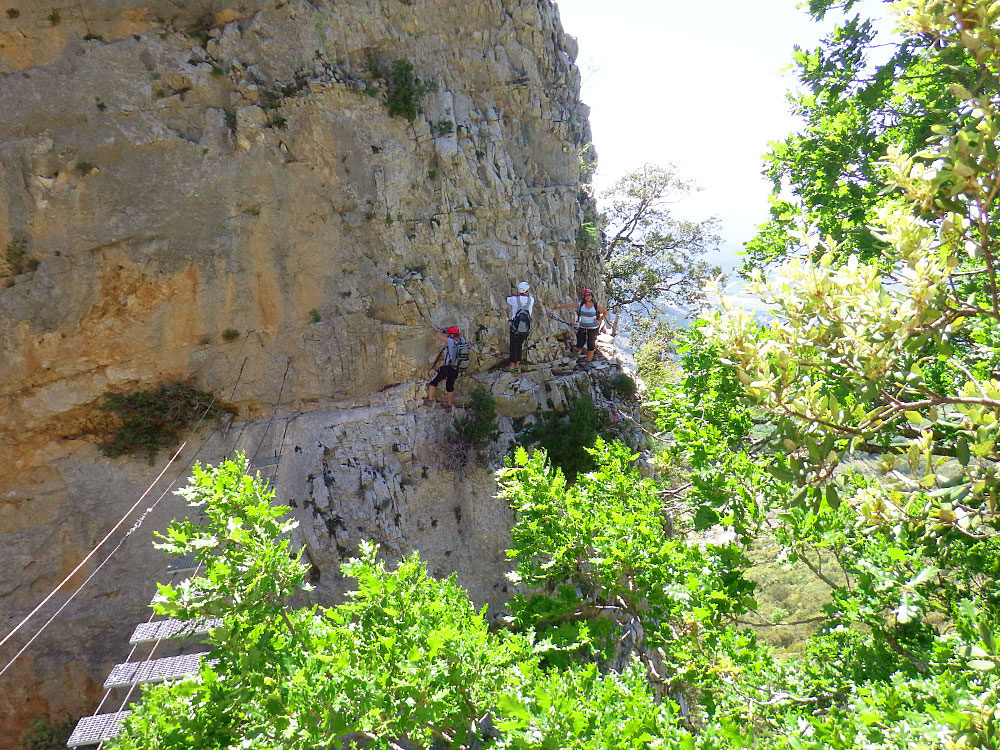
xmin=0 ymin=0 xmax=599 ymax=747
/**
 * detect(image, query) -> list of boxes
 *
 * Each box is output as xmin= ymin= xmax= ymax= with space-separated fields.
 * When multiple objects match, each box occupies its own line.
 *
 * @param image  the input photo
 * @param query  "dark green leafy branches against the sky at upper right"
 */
xmin=746 ymin=3 xmax=980 ymax=268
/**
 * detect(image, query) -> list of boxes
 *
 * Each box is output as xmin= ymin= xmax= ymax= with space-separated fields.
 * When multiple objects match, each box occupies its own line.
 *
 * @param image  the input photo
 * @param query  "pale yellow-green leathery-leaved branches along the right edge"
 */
xmin=710 ymin=3 xmax=1000 ymax=538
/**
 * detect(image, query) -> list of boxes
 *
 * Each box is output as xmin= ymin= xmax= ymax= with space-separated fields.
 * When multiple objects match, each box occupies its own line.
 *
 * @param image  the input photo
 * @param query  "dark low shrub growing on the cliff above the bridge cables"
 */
xmin=98 ymin=383 xmax=225 ymax=463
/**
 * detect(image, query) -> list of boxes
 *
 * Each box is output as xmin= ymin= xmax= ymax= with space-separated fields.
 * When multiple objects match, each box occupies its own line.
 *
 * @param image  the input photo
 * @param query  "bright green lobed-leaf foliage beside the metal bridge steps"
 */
xmin=114 ymin=457 xmax=624 ymax=750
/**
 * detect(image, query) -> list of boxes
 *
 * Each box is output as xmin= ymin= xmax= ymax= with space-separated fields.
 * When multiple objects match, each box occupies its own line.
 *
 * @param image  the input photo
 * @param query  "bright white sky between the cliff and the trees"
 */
xmin=557 ymin=0 xmax=883 ymax=268
